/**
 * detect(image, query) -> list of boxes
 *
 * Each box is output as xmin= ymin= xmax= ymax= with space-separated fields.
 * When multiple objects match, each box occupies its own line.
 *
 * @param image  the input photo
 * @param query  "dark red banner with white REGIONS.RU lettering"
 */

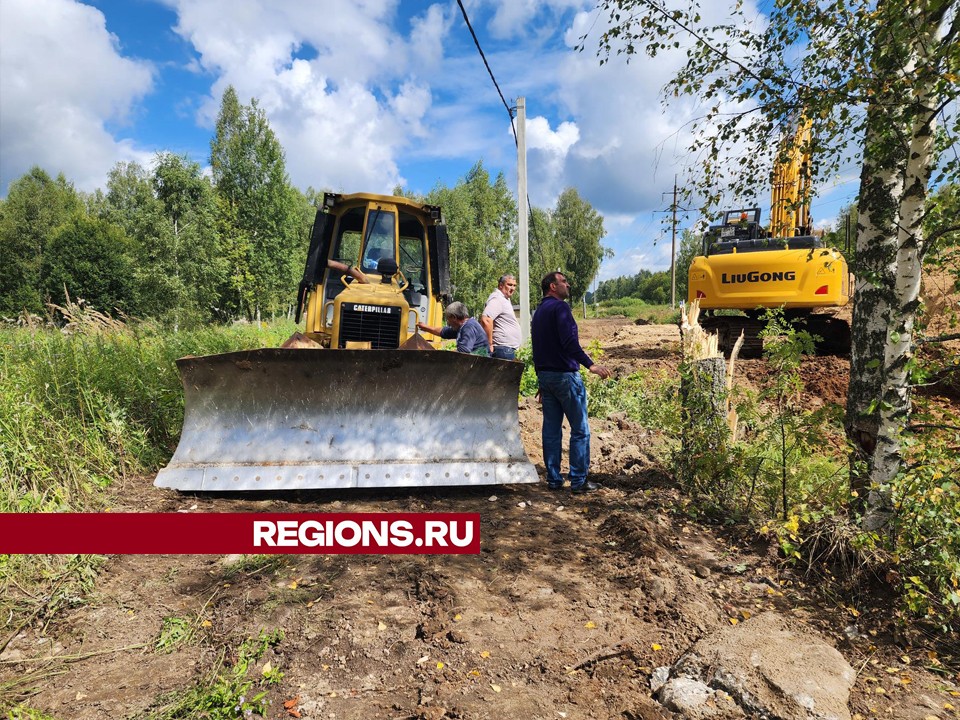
xmin=0 ymin=513 xmax=480 ymax=555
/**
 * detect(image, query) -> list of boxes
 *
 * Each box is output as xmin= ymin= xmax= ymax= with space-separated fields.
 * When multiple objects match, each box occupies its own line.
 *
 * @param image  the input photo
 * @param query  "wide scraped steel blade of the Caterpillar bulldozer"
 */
xmin=154 ymin=348 xmax=537 ymax=492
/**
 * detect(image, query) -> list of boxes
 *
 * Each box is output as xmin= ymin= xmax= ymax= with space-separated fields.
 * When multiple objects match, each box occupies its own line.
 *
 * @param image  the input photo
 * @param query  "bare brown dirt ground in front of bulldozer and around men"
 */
xmin=0 ymin=318 xmax=960 ymax=720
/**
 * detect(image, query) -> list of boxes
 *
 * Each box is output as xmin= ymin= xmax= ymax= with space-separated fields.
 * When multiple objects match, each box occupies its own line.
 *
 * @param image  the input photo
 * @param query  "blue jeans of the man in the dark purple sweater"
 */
xmin=537 ymin=370 xmax=590 ymax=488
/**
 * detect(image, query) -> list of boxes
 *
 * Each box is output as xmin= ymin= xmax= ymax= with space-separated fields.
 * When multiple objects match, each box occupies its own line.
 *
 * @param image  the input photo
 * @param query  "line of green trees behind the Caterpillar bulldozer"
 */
xmin=0 ymin=87 xmax=608 ymax=328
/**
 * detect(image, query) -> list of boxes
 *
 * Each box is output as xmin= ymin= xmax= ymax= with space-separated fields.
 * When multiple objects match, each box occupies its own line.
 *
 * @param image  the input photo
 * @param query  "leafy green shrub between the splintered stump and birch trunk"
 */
xmin=674 ymin=311 xmax=847 ymax=524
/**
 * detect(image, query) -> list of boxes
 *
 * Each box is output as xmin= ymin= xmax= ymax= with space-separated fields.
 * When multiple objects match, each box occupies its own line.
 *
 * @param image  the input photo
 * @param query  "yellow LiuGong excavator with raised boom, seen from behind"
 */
xmin=687 ymin=120 xmax=850 ymax=357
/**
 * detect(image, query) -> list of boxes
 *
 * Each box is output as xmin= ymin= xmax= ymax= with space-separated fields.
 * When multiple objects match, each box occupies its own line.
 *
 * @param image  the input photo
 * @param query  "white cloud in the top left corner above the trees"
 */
xmin=0 ymin=0 xmax=153 ymax=194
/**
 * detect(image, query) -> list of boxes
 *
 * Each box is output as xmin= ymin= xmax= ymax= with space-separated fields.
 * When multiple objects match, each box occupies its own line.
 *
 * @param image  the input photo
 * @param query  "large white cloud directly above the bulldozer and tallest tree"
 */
xmin=164 ymin=0 xmax=450 ymax=192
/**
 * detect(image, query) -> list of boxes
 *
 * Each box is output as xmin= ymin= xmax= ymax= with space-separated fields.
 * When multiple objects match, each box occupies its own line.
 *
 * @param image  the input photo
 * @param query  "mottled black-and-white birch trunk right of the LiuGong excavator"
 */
xmin=847 ymin=2 xmax=939 ymax=530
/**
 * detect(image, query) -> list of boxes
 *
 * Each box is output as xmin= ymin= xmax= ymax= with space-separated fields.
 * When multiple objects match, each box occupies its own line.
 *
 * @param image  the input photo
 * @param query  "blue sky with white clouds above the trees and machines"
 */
xmin=0 ymin=0 xmax=857 ymax=279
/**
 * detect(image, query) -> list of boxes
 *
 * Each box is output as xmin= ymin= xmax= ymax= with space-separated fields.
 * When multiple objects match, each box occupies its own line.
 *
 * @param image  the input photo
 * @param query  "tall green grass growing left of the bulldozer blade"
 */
xmin=0 ymin=323 xmax=294 ymax=512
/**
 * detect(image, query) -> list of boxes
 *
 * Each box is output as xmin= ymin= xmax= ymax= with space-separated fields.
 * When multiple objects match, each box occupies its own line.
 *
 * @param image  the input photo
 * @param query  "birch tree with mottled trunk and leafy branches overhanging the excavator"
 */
xmin=584 ymin=0 xmax=960 ymax=528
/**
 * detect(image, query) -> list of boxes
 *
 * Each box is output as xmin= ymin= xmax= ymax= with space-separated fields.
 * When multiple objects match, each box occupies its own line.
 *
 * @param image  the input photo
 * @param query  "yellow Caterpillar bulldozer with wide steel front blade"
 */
xmin=155 ymin=193 xmax=537 ymax=492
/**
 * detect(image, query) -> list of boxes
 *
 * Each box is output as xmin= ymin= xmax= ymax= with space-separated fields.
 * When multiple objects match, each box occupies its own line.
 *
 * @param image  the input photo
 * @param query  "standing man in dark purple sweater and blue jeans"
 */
xmin=530 ymin=272 xmax=612 ymax=494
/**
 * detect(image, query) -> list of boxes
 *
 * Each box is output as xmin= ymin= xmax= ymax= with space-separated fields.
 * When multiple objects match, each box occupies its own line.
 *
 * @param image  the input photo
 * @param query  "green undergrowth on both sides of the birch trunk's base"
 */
xmin=673 ymin=312 xmax=960 ymax=640
